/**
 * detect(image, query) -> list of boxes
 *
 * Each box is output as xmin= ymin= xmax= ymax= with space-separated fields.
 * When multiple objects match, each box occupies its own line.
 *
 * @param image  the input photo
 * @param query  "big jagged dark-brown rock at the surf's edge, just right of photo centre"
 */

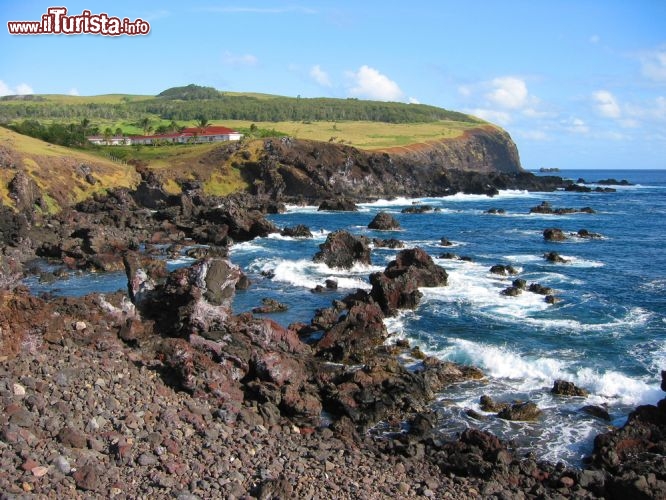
xmin=370 ymin=248 xmax=448 ymax=316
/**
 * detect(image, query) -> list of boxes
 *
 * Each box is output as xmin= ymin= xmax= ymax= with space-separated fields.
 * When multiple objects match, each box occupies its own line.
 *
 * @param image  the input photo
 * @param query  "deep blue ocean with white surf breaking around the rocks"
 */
xmin=27 ymin=170 xmax=666 ymax=465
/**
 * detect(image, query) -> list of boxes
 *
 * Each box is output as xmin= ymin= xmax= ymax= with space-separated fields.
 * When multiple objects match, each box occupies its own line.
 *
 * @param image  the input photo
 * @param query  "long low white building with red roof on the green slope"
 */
xmin=88 ymin=125 xmax=243 ymax=146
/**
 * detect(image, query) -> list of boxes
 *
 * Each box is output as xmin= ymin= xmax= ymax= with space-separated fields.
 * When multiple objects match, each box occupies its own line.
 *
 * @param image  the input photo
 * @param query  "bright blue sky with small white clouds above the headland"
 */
xmin=0 ymin=0 xmax=666 ymax=169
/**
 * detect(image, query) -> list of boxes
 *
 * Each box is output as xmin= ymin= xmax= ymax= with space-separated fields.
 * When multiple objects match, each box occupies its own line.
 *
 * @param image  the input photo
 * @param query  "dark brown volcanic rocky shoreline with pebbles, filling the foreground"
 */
xmin=0 ymin=170 xmax=666 ymax=499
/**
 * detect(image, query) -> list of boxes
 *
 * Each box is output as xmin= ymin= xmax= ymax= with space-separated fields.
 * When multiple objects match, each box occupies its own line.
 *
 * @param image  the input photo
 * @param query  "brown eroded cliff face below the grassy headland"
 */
xmin=238 ymin=126 xmax=552 ymax=201
